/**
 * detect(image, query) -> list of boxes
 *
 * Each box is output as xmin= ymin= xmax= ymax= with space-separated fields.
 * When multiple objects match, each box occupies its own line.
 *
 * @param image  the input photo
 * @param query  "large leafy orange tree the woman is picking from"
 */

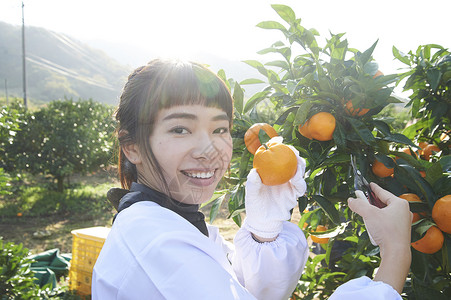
xmin=212 ymin=5 xmax=448 ymax=299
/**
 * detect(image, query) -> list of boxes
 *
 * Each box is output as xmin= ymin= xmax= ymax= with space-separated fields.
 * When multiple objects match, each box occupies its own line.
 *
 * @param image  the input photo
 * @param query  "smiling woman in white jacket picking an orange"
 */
xmin=92 ymin=60 xmax=410 ymax=299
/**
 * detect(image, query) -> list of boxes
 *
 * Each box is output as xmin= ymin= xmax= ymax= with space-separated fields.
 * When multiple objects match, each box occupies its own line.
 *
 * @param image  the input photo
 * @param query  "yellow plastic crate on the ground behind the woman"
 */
xmin=69 ymin=227 xmax=110 ymax=295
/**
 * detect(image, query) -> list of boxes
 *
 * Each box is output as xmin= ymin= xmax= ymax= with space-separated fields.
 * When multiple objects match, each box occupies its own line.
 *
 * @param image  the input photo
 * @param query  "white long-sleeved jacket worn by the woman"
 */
xmin=92 ymin=201 xmax=400 ymax=300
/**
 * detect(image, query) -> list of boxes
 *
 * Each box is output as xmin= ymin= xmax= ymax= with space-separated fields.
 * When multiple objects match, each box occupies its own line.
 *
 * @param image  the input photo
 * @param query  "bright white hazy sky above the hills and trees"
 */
xmin=0 ymin=0 xmax=451 ymax=74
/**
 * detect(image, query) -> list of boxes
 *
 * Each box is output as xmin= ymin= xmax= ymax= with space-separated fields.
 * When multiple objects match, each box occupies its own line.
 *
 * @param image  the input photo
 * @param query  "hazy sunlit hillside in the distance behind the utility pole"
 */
xmin=0 ymin=22 xmax=131 ymax=105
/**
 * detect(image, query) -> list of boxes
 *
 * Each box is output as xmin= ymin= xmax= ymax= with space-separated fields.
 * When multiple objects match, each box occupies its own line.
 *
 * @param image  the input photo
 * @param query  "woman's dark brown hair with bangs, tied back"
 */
xmin=115 ymin=59 xmax=233 ymax=195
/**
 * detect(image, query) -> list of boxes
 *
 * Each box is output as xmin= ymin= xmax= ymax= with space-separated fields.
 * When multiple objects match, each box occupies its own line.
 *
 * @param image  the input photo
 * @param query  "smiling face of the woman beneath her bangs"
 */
xmin=137 ymin=105 xmax=233 ymax=204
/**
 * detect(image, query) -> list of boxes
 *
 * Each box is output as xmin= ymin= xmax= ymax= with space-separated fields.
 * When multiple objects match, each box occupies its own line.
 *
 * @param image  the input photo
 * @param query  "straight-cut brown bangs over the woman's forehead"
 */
xmin=141 ymin=61 xmax=233 ymax=127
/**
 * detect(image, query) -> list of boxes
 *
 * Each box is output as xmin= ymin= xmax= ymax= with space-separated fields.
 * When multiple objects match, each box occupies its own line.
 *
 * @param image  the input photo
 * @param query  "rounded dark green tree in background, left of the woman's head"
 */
xmin=2 ymin=100 xmax=114 ymax=192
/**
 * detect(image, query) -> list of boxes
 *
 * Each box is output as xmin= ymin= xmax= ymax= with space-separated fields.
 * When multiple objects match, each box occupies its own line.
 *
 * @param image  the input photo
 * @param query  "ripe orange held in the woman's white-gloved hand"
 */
xmin=254 ymin=142 xmax=298 ymax=185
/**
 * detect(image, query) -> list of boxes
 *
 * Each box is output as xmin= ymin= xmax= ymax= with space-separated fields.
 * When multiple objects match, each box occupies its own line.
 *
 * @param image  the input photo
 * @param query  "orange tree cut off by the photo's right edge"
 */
xmin=393 ymin=45 xmax=451 ymax=299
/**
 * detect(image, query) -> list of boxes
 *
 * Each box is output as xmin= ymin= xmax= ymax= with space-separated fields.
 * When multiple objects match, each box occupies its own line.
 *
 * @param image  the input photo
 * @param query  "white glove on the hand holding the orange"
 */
xmin=243 ymin=146 xmax=307 ymax=238
